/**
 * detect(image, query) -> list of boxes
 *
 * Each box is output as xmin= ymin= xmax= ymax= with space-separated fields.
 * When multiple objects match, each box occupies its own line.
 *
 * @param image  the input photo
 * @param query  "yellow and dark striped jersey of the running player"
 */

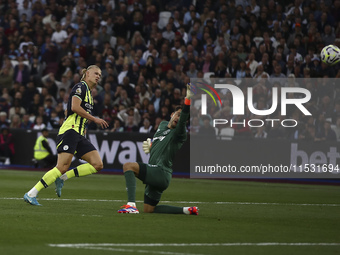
xmin=58 ymin=81 xmax=94 ymax=135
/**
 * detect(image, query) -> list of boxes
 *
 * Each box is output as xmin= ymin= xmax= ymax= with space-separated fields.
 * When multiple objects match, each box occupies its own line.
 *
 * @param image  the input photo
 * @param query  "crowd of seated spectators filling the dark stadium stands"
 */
xmin=0 ymin=0 xmax=340 ymax=141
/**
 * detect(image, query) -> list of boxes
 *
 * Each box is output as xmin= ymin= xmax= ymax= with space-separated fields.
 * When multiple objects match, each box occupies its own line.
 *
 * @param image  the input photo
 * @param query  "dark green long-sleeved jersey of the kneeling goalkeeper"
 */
xmin=149 ymin=105 xmax=190 ymax=173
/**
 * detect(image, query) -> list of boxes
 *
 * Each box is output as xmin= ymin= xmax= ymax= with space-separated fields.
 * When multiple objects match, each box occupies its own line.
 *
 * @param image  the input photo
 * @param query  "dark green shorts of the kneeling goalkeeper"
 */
xmin=137 ymin=162 xmax=172 ymax=206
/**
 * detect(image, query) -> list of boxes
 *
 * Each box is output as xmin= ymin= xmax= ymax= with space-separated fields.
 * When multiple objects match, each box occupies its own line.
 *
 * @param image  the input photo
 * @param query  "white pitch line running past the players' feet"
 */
xmin=0 ymin=197 xmax=340 ymax=207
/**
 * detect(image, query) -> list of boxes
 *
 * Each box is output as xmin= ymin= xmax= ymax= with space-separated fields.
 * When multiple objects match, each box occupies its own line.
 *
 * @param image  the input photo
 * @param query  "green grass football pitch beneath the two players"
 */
xmin=0 ymin=170 xmax=340 ymax=255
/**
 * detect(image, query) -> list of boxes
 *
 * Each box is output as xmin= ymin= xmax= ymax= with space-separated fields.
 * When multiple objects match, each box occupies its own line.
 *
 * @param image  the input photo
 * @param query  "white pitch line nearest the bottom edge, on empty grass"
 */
xmin=48 ymin=242 xmax=340 ymax=248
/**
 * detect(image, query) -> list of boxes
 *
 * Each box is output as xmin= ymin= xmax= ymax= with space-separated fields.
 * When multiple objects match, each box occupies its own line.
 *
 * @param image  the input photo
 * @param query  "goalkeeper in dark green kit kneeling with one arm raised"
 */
xmin=118 ymin=84 xmax=198 ymax=215
